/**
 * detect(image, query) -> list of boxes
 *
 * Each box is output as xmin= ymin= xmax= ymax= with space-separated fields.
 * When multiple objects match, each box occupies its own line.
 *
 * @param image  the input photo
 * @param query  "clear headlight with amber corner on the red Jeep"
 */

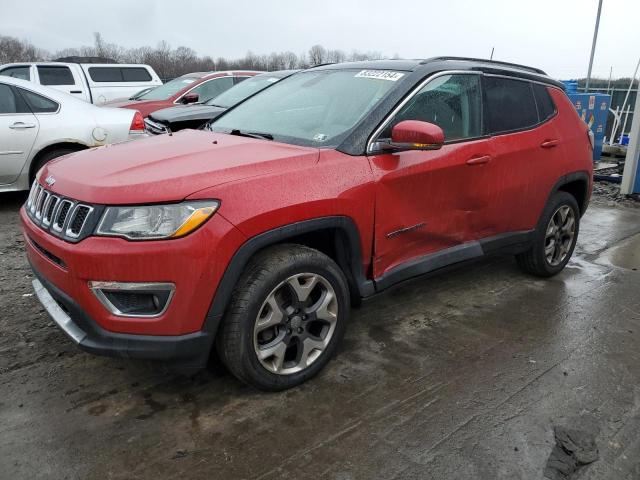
xmin=96 ymin=200 xmax=220 ymax=240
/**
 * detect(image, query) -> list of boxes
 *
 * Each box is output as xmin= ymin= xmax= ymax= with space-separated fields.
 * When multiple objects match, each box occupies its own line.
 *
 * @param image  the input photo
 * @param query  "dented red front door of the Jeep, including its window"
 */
xmin=369 ymin=73 xmax=493 ymax=278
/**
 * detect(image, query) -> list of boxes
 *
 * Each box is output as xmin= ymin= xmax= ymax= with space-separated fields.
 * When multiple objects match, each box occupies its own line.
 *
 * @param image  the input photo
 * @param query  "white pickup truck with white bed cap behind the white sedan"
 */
xmin=0 ymin=62 xmax=162 ymax=105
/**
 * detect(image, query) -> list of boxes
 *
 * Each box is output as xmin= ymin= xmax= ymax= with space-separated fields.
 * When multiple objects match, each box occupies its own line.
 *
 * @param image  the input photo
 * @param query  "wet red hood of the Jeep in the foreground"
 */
xmin=39 ymin=130 xmax=319 ymax=205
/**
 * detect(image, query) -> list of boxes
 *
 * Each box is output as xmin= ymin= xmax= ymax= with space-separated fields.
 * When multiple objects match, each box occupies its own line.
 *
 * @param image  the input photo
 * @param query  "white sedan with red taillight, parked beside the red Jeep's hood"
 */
xmin=0 ymin=77 xmax=146 ymax=192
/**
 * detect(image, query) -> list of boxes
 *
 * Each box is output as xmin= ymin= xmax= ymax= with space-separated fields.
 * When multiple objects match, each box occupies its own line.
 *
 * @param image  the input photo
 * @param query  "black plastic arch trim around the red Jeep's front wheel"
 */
xmin=203 ymin=216 xmax=375 ymax=338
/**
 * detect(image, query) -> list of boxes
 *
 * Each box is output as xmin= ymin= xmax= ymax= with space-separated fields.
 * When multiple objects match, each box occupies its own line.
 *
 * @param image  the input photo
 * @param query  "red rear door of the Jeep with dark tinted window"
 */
xmin=479 ymin=75 xmax=562 ymax=238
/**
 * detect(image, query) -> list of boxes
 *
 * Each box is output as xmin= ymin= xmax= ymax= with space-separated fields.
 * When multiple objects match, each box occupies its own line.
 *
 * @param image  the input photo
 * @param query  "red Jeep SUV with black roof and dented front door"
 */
xmin=21 ymin=57 xmax=592 ymax=390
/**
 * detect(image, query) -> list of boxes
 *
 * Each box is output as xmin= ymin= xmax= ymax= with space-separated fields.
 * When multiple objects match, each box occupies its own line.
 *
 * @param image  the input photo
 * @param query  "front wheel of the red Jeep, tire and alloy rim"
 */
xmin=216 ymin=244 xmax=350 ymax=391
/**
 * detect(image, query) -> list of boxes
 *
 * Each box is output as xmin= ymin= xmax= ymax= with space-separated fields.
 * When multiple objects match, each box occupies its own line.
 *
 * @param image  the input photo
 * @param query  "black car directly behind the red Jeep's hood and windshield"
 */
xmin=144 ymin=70 xmax=298 ymax=135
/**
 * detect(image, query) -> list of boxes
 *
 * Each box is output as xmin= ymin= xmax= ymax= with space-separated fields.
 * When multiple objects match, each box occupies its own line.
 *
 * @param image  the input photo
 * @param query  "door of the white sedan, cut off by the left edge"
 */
xmin=0 ymin=83 xmax=39 ymax=185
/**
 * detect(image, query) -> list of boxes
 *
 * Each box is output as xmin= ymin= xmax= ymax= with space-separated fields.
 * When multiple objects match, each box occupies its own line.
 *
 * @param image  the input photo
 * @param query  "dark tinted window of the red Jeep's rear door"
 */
xmin=484 ymin=77 xmax=538 ymax=134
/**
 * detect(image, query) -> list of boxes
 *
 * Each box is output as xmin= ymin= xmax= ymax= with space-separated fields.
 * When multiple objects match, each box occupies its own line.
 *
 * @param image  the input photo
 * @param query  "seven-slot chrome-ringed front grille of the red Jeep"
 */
xmin=25 ymin=182 xmax=102 ymax=242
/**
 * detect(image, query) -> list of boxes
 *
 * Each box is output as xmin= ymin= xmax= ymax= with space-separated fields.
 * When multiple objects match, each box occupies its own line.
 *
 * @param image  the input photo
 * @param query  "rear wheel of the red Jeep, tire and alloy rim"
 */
xmin=516 ymin=192 xmax=580 ymax=277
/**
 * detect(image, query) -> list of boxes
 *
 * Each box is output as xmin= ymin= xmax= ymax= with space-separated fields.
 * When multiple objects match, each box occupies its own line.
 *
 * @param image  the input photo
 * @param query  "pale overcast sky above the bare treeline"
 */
xmin=0 ymin=0 xmax=640 ymax=78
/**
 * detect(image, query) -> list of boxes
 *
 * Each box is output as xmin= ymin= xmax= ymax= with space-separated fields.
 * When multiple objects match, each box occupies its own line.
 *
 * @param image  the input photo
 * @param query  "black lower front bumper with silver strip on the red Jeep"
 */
xmin=32 ymin=265 xmax=213 ymax=370
